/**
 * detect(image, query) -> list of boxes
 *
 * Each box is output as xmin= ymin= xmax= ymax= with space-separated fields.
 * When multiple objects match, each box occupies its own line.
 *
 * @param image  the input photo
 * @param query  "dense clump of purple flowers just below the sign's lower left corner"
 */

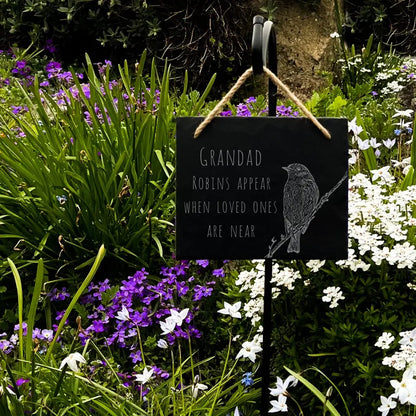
xmin=81 ymin=261 xmax=223 ymax=352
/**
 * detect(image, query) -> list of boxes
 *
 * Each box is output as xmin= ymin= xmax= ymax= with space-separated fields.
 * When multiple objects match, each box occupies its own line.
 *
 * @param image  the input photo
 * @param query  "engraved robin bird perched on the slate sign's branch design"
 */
xmin=283 ymin=163 xmax=319 ymax=253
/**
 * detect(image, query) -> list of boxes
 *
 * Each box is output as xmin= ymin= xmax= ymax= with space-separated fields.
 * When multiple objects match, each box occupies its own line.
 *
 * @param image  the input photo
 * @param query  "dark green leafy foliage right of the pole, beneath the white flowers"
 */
xmin=273 ymin=265 xmax=416 ymax=416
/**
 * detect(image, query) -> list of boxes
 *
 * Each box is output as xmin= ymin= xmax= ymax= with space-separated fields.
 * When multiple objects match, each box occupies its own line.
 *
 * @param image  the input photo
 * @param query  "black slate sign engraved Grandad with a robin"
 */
xmin=176 ymin=117 xmax=348 ymax=260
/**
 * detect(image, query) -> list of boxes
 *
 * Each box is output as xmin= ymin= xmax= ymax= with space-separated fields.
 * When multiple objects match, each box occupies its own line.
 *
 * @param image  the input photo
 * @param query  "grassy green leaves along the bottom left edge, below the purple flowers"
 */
xmin=0 ymin=255 xmax=260 ymax=416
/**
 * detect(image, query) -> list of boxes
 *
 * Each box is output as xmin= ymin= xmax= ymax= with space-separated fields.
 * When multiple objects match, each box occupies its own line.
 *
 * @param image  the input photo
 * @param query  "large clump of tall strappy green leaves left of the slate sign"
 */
xmin=0 ymin=52 xmax=212 ymax=284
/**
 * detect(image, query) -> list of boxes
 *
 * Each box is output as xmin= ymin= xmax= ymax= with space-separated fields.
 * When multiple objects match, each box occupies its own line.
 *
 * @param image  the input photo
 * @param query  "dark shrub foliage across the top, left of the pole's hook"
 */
xmin=0 ymin=0 xmax=254 ymax=88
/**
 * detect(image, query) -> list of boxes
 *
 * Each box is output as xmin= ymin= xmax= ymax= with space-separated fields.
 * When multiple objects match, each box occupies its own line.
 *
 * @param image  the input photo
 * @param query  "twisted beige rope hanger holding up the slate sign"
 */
xmin=194 ymin=66 xmax=331 ymax=139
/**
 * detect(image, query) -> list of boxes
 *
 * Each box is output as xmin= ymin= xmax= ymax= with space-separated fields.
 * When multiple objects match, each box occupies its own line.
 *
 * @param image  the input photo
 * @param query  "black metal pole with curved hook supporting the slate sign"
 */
xmin=252 ymin=16 xmax=277 ymax=416
